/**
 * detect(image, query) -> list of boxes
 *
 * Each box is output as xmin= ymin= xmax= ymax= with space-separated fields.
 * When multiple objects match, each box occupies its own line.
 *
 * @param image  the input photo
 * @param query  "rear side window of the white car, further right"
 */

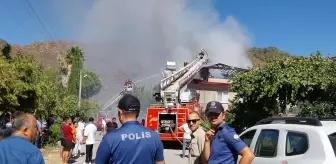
xmin=286 ymin=132 xmax=308 ymax=156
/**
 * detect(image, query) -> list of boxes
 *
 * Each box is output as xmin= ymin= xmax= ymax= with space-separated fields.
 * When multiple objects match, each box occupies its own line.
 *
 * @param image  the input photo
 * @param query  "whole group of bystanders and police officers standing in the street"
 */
xmin=0 ymin=94 xmax=254 ymax=164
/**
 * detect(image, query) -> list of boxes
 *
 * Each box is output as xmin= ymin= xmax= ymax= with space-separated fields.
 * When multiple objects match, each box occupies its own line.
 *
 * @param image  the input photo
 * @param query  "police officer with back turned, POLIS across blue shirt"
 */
xmin=95 ymin=94 xmax=165 ymax=164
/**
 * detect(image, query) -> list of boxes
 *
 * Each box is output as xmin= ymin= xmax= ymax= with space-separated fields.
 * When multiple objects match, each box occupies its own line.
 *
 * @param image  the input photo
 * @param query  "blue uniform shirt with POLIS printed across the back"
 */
xmin=95 ymin=121 xmax=164 ymax=164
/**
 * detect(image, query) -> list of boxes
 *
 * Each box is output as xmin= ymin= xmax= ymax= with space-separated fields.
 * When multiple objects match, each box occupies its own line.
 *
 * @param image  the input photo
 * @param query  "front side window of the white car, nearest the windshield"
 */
xmin=254 ymin=129 xmax=279 ymax=157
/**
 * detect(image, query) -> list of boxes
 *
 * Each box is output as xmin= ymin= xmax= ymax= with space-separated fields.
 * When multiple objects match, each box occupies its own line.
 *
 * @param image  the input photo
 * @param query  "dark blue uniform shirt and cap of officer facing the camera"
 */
xmin=206 ymin=101 xmax=247 ymax=164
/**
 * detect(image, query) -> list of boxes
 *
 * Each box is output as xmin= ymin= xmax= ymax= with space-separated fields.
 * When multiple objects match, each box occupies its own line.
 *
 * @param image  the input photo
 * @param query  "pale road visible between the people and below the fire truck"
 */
xmin=69 ymin=132 xmax=188 ymax=164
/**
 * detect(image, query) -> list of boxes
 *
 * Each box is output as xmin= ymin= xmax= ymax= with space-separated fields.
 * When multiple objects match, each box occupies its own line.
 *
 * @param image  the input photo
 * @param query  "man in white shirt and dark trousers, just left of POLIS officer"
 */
xmin=81 ymin=117 xmax=97 ymax=164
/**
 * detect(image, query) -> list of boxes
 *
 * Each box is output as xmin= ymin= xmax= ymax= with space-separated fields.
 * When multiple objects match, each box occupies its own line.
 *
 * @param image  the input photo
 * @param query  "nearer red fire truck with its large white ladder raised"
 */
xmin=146 ymin=50 xmax=208 ymax=141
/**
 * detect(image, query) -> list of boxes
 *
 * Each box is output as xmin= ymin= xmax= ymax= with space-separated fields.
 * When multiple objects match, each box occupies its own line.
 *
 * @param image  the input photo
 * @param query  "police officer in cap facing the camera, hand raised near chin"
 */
xmin=203 ymin=101 xmax=254 ymax=164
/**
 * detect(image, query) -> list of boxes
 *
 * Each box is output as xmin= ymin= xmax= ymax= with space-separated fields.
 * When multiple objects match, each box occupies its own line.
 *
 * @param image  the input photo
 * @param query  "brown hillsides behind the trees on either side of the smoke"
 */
xmin=0 ymin=39 xmax=290 ymax=68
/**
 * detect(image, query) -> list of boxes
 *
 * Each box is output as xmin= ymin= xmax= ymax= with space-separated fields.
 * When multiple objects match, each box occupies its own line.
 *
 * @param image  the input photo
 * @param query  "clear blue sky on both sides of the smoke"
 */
xmin=0 ymin=0 xmax=336 ymax=56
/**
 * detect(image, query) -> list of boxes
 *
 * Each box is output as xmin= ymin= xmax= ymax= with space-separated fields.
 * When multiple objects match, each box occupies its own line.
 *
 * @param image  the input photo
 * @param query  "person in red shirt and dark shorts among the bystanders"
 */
xmin=62 ymin=118 xmax=74 ymax=164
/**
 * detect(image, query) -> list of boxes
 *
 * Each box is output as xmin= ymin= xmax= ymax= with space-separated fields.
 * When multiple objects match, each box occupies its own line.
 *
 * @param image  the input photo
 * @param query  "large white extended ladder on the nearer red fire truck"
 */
xmin=160 ymin=49 xmax=209 ymax=107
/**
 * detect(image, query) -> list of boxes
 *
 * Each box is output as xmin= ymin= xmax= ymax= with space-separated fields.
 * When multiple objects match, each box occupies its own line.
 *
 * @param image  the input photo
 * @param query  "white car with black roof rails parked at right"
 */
xmin=240 ymin=117 xmax=336 ymax=164
